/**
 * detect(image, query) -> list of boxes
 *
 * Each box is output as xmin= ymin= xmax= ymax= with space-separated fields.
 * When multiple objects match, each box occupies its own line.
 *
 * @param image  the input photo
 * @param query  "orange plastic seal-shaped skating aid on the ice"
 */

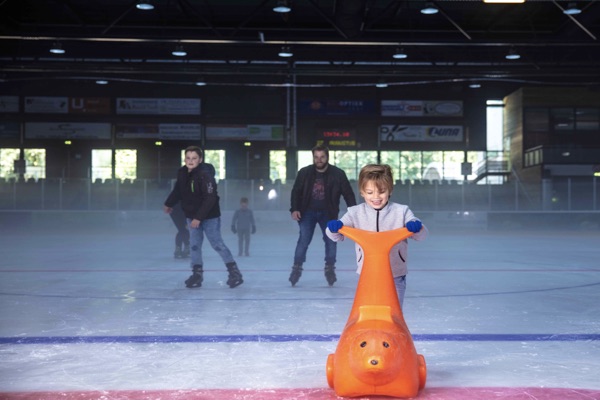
xmin=327 ymin=226 xmax=427 ymax=398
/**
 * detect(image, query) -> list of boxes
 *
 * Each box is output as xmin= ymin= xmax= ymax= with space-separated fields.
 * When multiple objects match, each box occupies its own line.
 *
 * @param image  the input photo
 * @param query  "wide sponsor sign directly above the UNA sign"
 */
xmin=381 ymin=100 xmax=463 ymax=117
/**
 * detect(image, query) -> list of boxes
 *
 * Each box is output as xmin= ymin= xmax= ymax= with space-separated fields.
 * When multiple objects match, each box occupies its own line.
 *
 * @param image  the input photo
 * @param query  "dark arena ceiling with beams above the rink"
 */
xmin=0 ymin=0 xmax=600 ymax=87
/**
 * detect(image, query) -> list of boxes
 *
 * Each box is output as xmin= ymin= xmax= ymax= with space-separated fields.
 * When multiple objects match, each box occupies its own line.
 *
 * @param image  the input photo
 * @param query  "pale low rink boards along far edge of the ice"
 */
xmin=0 ymin=209 xmax=600 ymax=232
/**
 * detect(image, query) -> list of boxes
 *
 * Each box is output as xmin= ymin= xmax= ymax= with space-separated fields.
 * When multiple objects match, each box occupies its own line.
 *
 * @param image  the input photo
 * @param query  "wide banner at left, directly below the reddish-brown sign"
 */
xmin=25 ymin=122 xmax=110 ymax=139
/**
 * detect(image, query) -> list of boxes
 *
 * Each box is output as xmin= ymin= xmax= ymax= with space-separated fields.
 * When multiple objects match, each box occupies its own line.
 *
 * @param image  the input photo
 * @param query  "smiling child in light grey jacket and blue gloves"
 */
xmin=325 ymin=164 xmax=428 ymax=307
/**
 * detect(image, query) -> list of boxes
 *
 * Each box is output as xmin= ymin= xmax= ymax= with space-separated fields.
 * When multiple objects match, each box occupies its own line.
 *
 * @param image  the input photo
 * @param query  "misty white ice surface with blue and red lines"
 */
xmin=0 ymin=212 xmax=600 ymax=400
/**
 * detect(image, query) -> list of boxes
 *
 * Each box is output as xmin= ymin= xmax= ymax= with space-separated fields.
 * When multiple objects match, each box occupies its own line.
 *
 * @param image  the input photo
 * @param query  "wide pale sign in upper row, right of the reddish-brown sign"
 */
xmin=116 ymin=97 xmax=200 ymax=115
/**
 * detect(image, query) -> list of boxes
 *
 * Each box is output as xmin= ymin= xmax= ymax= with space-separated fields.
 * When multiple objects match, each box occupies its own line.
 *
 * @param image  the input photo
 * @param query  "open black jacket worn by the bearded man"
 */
xmin=290 ymin=164 xmax=356 ymax=219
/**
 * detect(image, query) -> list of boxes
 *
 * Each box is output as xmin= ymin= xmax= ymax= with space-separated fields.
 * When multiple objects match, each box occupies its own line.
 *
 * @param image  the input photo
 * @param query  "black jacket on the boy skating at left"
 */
xmin=165 ymin=163 xmax=221 ymax=221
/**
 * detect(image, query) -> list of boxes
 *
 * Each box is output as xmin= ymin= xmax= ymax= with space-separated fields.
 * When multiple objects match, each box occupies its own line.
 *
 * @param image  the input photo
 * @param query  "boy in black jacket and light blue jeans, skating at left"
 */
xmin=164 ymin=146 xmax=244 ymax=288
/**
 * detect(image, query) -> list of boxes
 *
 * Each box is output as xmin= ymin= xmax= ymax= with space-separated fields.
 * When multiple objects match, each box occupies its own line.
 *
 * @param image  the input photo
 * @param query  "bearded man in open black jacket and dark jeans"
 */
xmin=289 ymin=146 xmax=356 ymax=286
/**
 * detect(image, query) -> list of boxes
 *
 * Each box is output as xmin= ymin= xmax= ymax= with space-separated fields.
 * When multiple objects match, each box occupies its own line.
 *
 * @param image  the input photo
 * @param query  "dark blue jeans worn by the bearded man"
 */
xmin=294 ymin=211 xmax=337 ymax=265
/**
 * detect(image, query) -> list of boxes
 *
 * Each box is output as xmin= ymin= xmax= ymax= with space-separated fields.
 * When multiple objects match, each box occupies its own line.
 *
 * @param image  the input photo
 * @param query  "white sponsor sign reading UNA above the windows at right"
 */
xmin=379 ymin=125 xmax=464 ymax=143
